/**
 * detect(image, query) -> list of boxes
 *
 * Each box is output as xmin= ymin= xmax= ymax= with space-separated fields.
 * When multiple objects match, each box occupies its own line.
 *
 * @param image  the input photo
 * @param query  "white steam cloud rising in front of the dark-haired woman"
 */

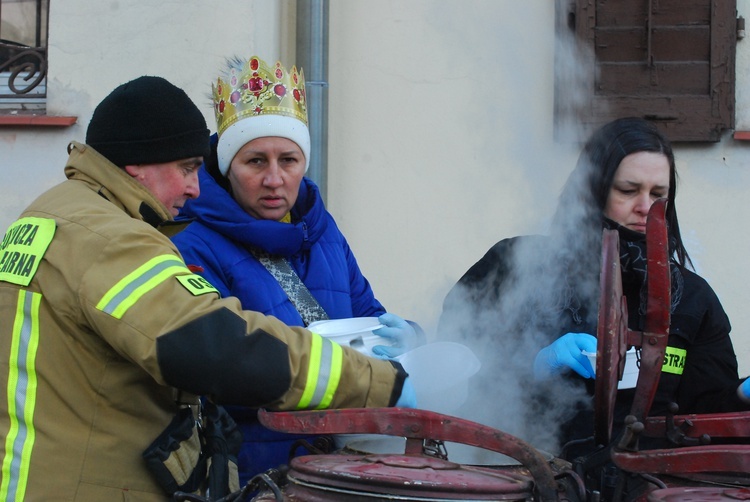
xmin=438 ymin=13 xmax=600 ymax=454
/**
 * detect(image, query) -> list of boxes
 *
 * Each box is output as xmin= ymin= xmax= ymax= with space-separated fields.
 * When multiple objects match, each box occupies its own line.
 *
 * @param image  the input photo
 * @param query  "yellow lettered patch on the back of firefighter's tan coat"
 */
xmin=0 ymin=217 xmax=57 ymax=286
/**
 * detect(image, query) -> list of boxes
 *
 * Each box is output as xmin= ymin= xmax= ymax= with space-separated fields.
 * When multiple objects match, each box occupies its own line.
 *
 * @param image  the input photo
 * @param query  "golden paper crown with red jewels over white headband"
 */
xmin=212 ymin=56 xmax=307 ymax=136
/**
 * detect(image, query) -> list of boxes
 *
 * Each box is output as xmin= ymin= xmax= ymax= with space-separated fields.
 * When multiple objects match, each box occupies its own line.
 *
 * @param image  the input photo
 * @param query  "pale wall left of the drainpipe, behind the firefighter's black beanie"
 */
xmin=0 ymin=0 xmax=294 ymax=237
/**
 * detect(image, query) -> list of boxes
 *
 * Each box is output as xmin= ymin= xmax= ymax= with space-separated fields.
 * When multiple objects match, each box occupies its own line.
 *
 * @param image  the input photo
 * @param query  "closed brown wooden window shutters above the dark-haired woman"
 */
xmin=555 ymin=0 xmax=737 ymax=141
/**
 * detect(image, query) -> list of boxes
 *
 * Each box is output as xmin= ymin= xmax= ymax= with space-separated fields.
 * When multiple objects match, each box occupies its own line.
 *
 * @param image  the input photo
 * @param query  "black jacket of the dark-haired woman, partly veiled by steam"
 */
xmin=438 ymin=229 xmax=750 ymax=447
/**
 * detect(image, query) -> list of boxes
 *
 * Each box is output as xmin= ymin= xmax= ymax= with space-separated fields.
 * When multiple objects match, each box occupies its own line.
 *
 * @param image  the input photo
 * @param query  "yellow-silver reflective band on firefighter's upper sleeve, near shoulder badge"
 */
xmin=96 ymin=254 xmax=191 ymax=319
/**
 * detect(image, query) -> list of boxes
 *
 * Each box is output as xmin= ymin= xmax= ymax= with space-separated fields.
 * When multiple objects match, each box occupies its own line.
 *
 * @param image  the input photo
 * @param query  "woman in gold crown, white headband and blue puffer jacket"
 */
xmin=174 ymin=56 xmax=424 ymax=490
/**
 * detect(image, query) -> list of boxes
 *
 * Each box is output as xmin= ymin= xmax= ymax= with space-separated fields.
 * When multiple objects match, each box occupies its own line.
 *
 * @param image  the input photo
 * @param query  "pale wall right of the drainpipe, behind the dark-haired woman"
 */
xmin=328 ymin=0 xmax=750 ymax=373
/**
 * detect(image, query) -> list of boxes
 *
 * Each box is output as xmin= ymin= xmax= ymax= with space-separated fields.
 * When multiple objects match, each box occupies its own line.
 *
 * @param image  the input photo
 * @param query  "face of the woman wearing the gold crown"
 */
xmin=227 ymin=136 xmax=305 ymax=221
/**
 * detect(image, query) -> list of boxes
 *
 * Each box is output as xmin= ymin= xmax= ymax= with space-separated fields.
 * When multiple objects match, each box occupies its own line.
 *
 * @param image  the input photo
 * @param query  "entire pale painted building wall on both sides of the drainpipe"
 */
xmin=0 ymin=0 xmax=750 ymax=374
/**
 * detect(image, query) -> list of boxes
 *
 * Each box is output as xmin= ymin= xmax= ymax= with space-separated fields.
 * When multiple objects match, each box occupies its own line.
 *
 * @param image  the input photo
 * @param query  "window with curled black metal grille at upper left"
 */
xmin=0 ymin=0 xmax=49 ymax=113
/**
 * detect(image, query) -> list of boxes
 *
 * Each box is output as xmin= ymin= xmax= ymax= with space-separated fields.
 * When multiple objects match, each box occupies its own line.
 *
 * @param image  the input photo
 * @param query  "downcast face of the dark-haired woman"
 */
xmin=604 ymin=152 xmax=669 ymax=233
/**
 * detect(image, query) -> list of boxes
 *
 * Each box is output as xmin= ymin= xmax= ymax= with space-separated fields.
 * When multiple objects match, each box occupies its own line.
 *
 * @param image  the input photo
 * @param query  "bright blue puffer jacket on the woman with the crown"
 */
xmin=173 ymin=163 xmax=385 ymax=485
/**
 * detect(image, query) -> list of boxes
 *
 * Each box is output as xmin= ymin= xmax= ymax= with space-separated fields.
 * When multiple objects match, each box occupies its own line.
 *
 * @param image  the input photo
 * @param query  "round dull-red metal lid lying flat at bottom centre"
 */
xmin=287 ymin=454 xmax=533 ymax=500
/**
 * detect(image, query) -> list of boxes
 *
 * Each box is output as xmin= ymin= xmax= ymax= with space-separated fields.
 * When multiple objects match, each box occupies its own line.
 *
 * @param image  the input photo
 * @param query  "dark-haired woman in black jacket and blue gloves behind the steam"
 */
xmin=438 ymin=118 xmax=750 ymax=464
